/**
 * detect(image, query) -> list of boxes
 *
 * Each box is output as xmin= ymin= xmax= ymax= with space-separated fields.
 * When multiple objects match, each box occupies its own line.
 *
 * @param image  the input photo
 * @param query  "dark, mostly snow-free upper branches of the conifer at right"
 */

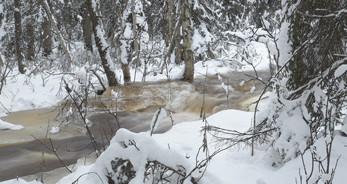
xmin=284 ymin=0 xmax=347 ymax=89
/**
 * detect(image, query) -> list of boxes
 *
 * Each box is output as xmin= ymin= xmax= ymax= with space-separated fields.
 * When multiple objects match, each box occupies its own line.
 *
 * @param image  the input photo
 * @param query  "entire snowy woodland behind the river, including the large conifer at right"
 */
xmin=0 ymin=0 xmax=347 ymax=183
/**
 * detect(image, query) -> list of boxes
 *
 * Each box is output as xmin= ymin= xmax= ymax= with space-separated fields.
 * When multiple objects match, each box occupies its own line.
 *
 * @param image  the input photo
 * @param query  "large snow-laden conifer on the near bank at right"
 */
xmin=249 ymin=0 xmax=346 ymax=166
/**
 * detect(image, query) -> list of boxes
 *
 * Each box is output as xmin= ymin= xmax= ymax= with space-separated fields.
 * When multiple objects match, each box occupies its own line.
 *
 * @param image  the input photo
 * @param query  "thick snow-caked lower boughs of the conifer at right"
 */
xmin=256 ymin=77 xmax=311 ymax=164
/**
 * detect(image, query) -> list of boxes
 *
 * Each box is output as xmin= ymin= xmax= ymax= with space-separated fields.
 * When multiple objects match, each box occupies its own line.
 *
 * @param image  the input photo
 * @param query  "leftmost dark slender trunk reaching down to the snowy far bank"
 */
xmin=14 ymin=0 xmax=25 ymax=74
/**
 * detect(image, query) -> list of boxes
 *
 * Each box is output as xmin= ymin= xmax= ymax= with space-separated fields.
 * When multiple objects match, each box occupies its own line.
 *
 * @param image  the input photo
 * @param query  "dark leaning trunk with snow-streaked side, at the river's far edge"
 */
xmin=86 ymin=0 xmax=118 ymax=86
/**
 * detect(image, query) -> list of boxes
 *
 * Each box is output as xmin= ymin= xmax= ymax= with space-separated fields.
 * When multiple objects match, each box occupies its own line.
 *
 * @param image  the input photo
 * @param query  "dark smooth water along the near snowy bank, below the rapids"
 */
xmin=0 ymin=108 xmax=179 ymax=181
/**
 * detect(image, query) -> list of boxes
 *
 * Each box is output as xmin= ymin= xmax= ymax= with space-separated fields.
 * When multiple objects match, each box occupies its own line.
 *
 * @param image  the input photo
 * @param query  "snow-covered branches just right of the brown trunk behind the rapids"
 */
xmin=191 ymin=0 xmax=254 ymax=64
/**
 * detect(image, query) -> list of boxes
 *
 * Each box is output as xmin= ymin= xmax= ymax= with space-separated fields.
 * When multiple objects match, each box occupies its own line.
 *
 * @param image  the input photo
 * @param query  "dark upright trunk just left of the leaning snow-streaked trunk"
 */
xmin=82 ymin=4 xmax=93 ymax=53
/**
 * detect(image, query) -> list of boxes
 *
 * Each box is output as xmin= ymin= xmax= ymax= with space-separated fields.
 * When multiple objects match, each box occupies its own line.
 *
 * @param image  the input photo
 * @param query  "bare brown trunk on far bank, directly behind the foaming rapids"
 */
xmin=182 ymin=0 xmax=194 ymax=81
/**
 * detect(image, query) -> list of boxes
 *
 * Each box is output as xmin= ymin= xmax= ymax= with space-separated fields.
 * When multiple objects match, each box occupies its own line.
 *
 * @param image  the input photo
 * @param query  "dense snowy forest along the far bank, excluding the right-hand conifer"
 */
xmin=0 ymin=0 xmax=280 ymax=86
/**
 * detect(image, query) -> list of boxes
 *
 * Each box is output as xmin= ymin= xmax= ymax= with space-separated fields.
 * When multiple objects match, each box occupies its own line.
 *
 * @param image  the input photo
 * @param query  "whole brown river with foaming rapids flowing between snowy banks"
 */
xmin=0 ymin=72 xmax=269 ymax=183
